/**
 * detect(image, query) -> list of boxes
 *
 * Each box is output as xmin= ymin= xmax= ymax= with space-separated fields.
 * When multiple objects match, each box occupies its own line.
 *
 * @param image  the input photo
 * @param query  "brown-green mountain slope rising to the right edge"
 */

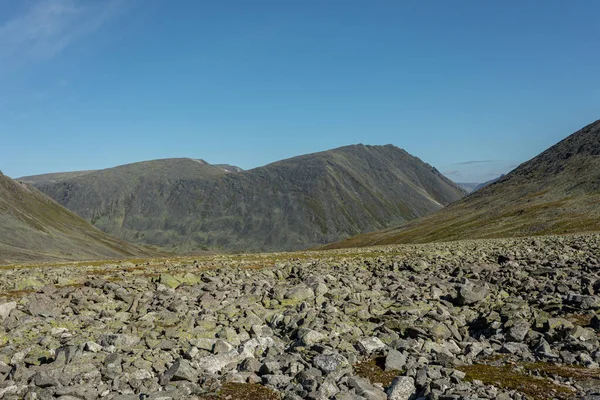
xmin=325 ymin=120 xmax=600 ymax=248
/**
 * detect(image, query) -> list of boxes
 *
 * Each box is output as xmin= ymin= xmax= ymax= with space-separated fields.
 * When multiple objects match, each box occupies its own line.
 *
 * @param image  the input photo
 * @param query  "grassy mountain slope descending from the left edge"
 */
xmin=0 ymin=173 xmax=158 ymax=264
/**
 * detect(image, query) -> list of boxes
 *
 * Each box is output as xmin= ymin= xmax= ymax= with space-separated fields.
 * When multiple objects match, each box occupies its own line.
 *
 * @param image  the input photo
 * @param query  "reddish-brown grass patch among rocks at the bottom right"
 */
xmin=457 ymin=364 xmax=575 ymax=400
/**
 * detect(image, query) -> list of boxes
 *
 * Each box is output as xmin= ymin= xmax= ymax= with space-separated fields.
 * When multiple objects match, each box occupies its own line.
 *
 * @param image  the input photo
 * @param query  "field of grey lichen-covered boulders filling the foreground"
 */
xmin=0 ymin=235 xmax=600 ymax=400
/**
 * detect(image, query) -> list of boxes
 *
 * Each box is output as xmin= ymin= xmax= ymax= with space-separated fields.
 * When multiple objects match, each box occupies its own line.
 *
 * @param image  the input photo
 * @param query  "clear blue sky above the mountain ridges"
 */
xmin=0 ymin=0 xmax=600 ymax=182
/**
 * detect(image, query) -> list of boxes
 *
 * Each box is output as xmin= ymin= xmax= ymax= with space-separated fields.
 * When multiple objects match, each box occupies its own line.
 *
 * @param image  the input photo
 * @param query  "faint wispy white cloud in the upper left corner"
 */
xmin=0 ymin=0 xmax=130 ymax=64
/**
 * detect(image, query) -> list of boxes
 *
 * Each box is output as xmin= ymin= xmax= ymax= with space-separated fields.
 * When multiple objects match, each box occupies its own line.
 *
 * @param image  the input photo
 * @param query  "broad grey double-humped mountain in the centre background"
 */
xmin=29 ymin=145 xmax=465 ymax=252
